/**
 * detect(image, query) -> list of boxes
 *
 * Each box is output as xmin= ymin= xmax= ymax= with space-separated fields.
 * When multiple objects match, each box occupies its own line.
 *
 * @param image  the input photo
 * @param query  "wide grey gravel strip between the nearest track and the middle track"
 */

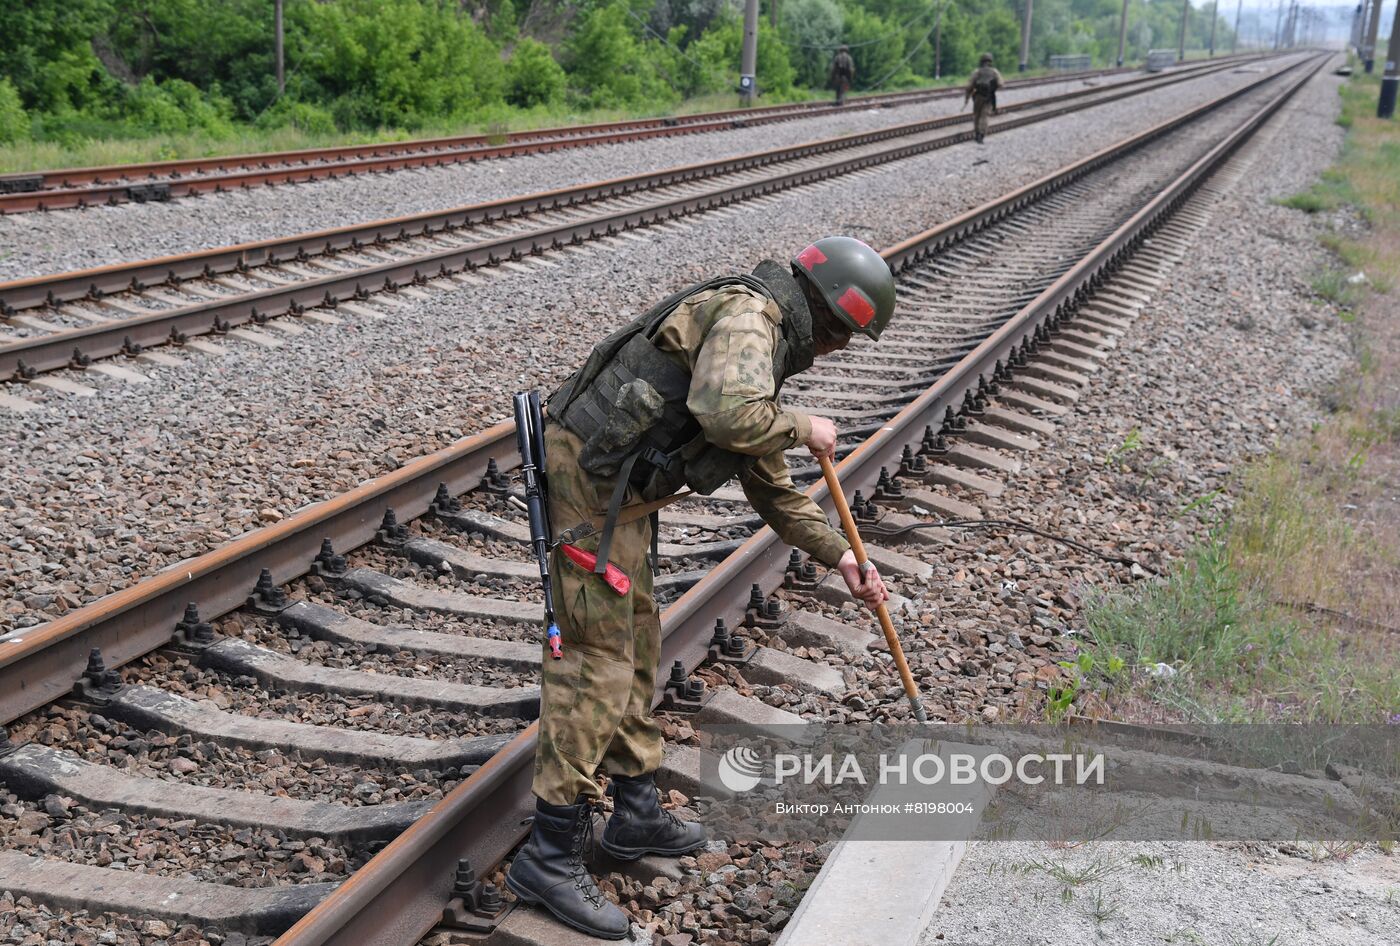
xmin=0 ymin=55 xmax=1326 ymax=628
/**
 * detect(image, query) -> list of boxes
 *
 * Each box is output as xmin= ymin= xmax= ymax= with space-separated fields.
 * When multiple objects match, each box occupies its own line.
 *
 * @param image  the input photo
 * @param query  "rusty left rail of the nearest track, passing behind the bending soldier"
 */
xmin=0 ymin=53 xmax=1310 ymax=723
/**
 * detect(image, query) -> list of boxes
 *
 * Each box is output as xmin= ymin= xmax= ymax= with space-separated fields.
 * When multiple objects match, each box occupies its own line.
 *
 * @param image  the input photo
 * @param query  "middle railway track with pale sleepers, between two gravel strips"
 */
xmin=0 ymin=53 xmax=1288 ymax=382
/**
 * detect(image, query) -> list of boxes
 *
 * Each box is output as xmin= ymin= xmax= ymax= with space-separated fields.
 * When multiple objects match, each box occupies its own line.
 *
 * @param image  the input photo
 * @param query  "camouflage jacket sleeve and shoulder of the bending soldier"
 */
xmin=652 ymin=285 xmax=850 ymax=565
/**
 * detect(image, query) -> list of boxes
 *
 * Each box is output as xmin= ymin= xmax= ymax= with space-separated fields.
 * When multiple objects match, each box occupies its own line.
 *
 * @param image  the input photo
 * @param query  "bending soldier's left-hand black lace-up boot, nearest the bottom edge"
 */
xmin=505 ymin=799 xmax=630 ymax=939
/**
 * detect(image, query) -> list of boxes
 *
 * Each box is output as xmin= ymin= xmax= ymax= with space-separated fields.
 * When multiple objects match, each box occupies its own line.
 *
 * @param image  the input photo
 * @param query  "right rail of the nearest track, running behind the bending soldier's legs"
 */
xmin=274 ymin=60 xmax=1326 ymax=946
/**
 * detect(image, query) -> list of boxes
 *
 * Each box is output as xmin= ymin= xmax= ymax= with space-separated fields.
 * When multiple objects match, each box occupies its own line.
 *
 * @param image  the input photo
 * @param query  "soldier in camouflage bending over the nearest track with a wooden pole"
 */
xmin=507 ymin=237 xmax=895 ymax=939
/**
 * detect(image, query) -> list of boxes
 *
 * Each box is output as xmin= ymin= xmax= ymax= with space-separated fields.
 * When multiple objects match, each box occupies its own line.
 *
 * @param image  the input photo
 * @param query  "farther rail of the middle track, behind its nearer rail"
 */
xmin=0 ymin=54 xmax=1248 ymax=315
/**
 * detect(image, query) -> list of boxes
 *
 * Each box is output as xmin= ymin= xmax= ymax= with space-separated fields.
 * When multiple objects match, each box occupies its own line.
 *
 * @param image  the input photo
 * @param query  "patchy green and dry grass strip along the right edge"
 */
xmin=1077 ymin=76 xmax=1400 ymax=722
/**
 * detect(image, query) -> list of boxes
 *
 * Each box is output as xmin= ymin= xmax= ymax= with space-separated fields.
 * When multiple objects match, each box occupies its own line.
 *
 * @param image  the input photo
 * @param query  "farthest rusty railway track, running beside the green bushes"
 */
xmin=0 ymin=56 xmax=1257 ymax=214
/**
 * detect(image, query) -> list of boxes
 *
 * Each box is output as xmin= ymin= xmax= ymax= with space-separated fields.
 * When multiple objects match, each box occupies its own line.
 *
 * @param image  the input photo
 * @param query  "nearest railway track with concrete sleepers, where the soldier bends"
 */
xmin=0 ymin=53 xmax=1322 ymax=946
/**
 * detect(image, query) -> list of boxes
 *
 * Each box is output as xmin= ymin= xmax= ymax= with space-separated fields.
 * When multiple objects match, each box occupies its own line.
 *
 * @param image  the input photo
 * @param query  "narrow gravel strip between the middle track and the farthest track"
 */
xmin=0 ymin=60 xmax=1288 ymax=278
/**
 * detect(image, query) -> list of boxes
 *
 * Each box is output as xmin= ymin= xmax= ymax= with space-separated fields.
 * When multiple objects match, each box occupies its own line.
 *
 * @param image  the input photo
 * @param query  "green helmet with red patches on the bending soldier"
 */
xmin=792 ymin=237 xmax=895 ymax=341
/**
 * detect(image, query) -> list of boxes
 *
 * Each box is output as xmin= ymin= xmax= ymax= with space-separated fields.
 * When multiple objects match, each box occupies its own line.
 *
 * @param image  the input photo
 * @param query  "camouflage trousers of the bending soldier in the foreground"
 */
xmin=533 ymin=423 xmax=661 ymax=805
